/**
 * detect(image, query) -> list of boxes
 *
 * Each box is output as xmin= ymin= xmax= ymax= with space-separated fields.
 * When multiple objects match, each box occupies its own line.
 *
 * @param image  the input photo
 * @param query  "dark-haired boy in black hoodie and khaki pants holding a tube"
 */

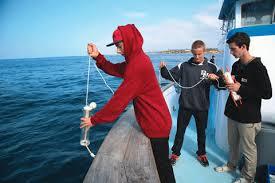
xmin=215 ymin=32 xmax=272 ymax=183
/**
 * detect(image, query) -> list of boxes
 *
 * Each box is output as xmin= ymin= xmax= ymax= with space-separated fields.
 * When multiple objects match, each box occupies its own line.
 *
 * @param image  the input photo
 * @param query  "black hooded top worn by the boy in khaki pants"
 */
xmin=224 ymin=57 xmax=272 ymax=123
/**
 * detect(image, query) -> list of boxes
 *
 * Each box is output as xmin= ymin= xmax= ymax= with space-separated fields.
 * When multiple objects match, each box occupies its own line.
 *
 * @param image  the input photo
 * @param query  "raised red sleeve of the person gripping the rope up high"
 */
xmin=95 ymin=54 xmax=126 ymax=78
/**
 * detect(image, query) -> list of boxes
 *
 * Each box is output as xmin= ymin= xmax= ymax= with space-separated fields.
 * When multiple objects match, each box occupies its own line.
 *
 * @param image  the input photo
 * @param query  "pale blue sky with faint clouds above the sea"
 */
xmin=0 ymin=0 xmax=222 ymax=59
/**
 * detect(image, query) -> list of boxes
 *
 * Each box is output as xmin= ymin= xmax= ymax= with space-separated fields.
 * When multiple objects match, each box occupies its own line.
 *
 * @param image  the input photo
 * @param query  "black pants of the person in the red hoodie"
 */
xmin=150 ymin=138 xmax=176 ymax=183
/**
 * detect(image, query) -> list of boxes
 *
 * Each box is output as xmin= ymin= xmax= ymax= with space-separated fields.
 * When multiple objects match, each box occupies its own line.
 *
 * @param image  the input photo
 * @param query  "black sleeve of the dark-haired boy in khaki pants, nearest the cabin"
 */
xmin=237 ymin=65 xmax=272 ymax=99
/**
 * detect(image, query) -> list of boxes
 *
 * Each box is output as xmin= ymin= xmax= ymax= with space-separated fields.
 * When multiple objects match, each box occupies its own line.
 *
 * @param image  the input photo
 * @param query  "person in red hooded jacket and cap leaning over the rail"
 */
xmin=80 ymin=24 xmax=175 ymax=183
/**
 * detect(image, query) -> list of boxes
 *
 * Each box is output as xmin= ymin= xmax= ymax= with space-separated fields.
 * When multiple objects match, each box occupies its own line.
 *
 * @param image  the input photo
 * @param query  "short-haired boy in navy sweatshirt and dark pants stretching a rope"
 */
xmin=160 ymin=40 xmax=223 ymax=166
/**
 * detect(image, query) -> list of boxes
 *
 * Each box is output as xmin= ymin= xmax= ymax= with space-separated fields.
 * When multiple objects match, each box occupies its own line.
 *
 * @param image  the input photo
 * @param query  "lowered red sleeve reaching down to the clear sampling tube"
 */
xmin=91 ymin=71 xmax=142 ymax=124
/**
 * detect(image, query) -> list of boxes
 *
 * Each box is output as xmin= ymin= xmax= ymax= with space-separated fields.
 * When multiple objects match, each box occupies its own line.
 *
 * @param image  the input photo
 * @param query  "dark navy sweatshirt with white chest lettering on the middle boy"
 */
xmin=161 ymin=58 xmax=224 ymax=111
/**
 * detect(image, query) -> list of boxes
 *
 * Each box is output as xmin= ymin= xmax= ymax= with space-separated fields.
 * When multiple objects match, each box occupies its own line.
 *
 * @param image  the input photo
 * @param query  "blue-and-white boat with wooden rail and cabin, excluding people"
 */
xmin=84 ymin=0 xmax=275 ymax=183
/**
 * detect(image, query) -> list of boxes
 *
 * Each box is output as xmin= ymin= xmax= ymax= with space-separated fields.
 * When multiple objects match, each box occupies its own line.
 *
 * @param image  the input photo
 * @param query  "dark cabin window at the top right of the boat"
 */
xmin=241 ymin=0 xmax=275 ymax=26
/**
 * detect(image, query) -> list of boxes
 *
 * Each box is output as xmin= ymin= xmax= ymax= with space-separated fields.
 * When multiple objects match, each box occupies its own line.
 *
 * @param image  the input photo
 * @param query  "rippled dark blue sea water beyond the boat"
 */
xmin=0 ymin=54 xmax=221 ymax=183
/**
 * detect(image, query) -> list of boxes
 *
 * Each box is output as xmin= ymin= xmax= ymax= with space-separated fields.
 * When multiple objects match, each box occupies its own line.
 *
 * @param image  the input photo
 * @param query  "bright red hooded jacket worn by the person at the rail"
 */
xmin=91 ymin=24 xmax=172 ymax=138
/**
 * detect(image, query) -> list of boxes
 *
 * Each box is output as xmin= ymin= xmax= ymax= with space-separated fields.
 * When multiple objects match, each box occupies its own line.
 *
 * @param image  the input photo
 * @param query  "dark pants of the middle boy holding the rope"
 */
xmin=172 ymin=105 xmax=208 ymax=156
